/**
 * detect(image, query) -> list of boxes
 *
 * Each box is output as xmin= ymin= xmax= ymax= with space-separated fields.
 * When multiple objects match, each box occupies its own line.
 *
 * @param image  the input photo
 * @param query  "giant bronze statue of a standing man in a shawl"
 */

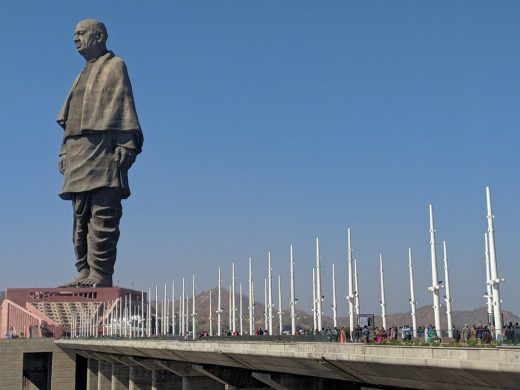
xmin=58 ymin=20 xmax=143 ymax=287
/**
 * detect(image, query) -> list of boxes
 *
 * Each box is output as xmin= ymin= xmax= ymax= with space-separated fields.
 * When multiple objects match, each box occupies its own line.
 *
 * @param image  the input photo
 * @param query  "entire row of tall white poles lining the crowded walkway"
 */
xmin=70 ymin=187 xmax=503 ymax=339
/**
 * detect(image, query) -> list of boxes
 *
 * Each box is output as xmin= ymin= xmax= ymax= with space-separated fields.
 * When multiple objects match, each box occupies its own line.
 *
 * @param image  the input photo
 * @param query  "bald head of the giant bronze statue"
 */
xmin=74 ymin=19 xmax=108 ymax=61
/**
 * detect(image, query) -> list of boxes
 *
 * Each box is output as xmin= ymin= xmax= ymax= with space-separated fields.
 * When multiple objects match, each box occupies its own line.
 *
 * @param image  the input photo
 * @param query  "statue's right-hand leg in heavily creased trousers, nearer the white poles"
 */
xmin=81 ymin=187 xmax=122 ymax=287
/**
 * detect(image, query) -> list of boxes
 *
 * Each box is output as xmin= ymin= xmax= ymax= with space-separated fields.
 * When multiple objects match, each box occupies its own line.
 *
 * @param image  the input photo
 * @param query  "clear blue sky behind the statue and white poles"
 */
xmin=0 ymin=0 xmax=520 ymax=315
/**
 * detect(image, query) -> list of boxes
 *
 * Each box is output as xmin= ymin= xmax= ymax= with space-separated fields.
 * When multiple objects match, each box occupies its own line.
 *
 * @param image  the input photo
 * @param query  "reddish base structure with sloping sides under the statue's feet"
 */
xmin=0 ymin=287 xmax=146 ymax=338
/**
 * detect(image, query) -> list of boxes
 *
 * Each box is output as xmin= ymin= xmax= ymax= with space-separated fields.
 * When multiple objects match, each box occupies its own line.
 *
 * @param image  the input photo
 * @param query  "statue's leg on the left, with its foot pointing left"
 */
xmin=62 ymin=192 xmax=90 ymax=287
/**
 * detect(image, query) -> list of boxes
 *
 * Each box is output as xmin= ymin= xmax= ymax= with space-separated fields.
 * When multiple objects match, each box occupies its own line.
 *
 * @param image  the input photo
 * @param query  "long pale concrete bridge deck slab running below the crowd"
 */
xmin=56 ymin=338 xmax=520 ymax=389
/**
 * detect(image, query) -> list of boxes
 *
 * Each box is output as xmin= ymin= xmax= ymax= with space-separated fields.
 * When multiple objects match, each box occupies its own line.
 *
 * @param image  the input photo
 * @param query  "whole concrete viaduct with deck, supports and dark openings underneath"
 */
xmin=0 ymin=338 xmax=520 ymax=390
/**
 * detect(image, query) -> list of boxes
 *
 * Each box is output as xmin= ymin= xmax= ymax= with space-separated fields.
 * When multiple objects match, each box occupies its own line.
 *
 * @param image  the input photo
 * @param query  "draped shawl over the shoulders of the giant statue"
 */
xmin=57 ymin=51 xmax=143 ymax=153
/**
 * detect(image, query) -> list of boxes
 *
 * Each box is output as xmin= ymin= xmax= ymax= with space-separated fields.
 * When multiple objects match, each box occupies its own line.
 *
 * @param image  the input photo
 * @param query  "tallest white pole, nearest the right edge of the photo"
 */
xmin=486 ymin=186 xmax=502 ymax=341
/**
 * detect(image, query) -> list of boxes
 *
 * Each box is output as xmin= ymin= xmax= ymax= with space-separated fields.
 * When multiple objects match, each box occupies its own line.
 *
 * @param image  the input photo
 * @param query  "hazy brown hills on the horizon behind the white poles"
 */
xmin=175 ymin=288 xmax=520 ymax=333
